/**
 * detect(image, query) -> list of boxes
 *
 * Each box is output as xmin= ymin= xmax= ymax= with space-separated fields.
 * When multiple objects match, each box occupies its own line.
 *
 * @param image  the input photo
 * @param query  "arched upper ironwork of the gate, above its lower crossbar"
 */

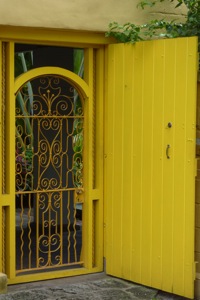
xmin=16 ymin=76 xmax=84 ymax=191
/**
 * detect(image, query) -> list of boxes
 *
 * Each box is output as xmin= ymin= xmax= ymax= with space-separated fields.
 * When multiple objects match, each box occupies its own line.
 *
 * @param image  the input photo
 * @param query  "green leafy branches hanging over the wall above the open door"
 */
xmin=106 ymin=0 xmax=200 ymax=47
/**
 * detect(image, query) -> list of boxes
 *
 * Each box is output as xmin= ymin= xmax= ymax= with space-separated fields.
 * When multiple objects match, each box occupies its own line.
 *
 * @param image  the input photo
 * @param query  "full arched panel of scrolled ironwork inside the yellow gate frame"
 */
xmin=15 ymin=75 xmax=84 ymax=271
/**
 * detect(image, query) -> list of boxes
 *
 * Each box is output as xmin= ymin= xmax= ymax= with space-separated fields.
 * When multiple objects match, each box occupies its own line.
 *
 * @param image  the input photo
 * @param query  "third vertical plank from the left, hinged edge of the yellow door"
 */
xmin=121 ymin=44 xmax=135 ymax=279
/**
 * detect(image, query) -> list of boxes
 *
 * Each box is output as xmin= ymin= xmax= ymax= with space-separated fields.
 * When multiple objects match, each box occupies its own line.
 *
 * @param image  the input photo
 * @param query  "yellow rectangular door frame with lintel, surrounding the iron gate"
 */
xmin=0 ymin=26 xmax=106 ymax=284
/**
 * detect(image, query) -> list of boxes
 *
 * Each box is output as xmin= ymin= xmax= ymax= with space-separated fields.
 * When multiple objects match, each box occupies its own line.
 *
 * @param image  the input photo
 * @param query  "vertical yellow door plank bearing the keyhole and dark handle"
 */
xmin=161 ymin=40 xmax=175 ymax=292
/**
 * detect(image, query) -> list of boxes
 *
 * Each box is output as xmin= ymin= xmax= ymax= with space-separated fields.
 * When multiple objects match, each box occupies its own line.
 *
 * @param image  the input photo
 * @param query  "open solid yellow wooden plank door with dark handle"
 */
xmin=105 ymin=38 xmax=197 ymax=298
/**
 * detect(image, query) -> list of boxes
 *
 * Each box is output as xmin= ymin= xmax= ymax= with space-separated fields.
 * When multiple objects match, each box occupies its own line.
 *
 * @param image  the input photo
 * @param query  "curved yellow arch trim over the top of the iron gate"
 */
xmin=15 ymin=67 xmax=89 ymax=98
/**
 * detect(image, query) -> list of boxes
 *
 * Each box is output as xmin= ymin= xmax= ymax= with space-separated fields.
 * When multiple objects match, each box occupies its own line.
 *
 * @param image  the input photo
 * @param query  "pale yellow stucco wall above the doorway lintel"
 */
xmin=0 ymin=0 xmax=188 ymax=31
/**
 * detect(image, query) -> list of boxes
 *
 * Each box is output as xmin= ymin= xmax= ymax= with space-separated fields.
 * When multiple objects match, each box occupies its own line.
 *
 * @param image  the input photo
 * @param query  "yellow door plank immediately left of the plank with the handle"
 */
xmin=151 ymin=41 xmax=165 ymax=289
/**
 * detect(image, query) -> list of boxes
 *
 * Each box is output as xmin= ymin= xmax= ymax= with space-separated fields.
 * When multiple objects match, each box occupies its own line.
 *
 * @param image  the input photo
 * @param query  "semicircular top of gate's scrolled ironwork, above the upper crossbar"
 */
xmin=16 ymin=76 xmax=83 ymax=116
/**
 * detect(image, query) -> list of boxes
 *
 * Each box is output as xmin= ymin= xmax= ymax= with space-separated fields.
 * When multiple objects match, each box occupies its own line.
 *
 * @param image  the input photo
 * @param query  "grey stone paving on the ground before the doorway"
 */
xmin=0 ymin=274 xmax=195 ymax=300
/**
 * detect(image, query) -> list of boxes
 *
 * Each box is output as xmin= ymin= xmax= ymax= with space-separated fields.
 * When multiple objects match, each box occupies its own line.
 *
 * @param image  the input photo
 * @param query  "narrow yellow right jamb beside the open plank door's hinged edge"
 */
xmin=92 ymin=48 xmax=105 ymax=270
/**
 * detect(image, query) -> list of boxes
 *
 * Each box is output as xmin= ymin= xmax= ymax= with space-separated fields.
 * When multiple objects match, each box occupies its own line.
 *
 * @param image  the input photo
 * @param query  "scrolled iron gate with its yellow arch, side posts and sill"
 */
xmin=0 ymin=39 xmax=104 ymax=284
